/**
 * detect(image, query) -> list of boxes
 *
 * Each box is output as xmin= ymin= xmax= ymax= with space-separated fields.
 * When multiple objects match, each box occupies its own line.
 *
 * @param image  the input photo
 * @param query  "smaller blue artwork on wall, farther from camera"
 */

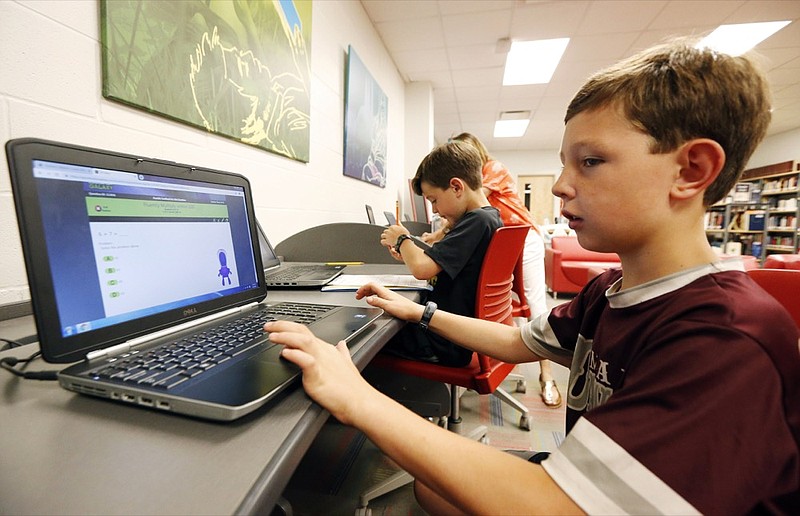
xmin=344 ymin=45 xmax=389 ymax=188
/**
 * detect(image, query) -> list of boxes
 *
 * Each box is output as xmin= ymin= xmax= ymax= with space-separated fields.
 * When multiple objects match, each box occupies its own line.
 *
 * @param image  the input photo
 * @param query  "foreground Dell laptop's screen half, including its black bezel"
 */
xmin=7 ymin=139 xmax=264 ymax=360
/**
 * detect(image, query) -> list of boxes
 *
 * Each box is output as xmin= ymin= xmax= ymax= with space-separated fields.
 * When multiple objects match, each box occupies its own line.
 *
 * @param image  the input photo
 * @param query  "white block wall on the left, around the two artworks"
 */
xmin=0 ymin=0 xmax=404 ymax=305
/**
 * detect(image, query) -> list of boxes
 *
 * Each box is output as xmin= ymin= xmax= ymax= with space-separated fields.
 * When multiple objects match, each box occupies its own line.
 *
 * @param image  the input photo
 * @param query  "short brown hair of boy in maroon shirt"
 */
xmin=564 ymin=39 xmax=771 ymax=206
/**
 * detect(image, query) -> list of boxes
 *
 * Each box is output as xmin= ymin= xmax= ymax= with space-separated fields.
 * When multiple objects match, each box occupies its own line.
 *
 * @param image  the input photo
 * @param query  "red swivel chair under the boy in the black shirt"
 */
xmin=371 ymin=226 xmax=530 ymax=432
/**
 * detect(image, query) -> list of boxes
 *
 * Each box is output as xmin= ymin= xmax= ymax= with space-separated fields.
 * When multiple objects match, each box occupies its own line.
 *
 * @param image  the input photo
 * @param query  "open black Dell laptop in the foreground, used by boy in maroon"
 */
xmin=6 ymin=139 xmax=381 ymax=420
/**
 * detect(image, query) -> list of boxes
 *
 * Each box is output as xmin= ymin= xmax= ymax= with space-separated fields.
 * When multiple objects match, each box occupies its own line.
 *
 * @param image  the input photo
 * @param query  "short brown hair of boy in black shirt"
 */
xmin=411 ymin=141 xmax=483 ymax=195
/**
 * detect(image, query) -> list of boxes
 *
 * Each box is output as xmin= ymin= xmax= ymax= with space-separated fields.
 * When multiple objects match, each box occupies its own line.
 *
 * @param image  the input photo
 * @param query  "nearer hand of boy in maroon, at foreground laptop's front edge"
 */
xmin=264 ymin=321 xmax=372 ymax=424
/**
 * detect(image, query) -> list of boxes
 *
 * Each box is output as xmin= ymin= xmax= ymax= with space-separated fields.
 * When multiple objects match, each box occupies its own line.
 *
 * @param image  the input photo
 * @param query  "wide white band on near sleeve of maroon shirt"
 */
xmin=542 ymin=418 xmax=699 ymax=514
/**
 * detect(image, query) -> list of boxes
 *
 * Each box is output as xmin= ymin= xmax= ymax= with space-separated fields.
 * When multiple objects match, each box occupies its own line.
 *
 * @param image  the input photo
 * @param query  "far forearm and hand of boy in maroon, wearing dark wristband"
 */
xmin=356 ymin=283 xmax=542 ymax=364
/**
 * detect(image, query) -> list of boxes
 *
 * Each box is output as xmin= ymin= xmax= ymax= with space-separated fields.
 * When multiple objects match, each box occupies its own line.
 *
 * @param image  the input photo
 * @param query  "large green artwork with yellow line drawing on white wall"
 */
xmin=100 ymin=0 xmax=311 ymax=162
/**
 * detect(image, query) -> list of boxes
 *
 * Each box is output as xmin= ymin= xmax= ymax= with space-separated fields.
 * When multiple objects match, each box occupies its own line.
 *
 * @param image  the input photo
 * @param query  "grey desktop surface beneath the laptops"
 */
xmin=0 ymin=274 xmax=416 ymax=514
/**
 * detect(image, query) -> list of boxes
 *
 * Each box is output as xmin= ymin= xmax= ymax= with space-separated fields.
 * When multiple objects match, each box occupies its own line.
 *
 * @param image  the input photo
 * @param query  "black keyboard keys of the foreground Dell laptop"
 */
xmin=90 ymin=303 xmax=336 ymax=389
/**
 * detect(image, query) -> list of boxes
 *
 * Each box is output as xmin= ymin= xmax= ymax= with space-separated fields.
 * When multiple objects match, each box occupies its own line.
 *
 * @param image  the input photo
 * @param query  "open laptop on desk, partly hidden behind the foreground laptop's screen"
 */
xmin=256 ymin=223 xmax=345 ymax=288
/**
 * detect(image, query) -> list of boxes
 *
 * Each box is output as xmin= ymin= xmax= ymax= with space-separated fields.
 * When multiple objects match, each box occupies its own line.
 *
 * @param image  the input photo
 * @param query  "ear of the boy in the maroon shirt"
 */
xmin=670 ymin=138 xmax=725 ymax=199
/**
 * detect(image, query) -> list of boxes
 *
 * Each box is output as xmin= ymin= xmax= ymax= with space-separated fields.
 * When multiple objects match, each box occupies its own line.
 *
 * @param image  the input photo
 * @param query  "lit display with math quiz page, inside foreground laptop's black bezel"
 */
xmin=33 ymin=160 xmax=258 ymax=337
